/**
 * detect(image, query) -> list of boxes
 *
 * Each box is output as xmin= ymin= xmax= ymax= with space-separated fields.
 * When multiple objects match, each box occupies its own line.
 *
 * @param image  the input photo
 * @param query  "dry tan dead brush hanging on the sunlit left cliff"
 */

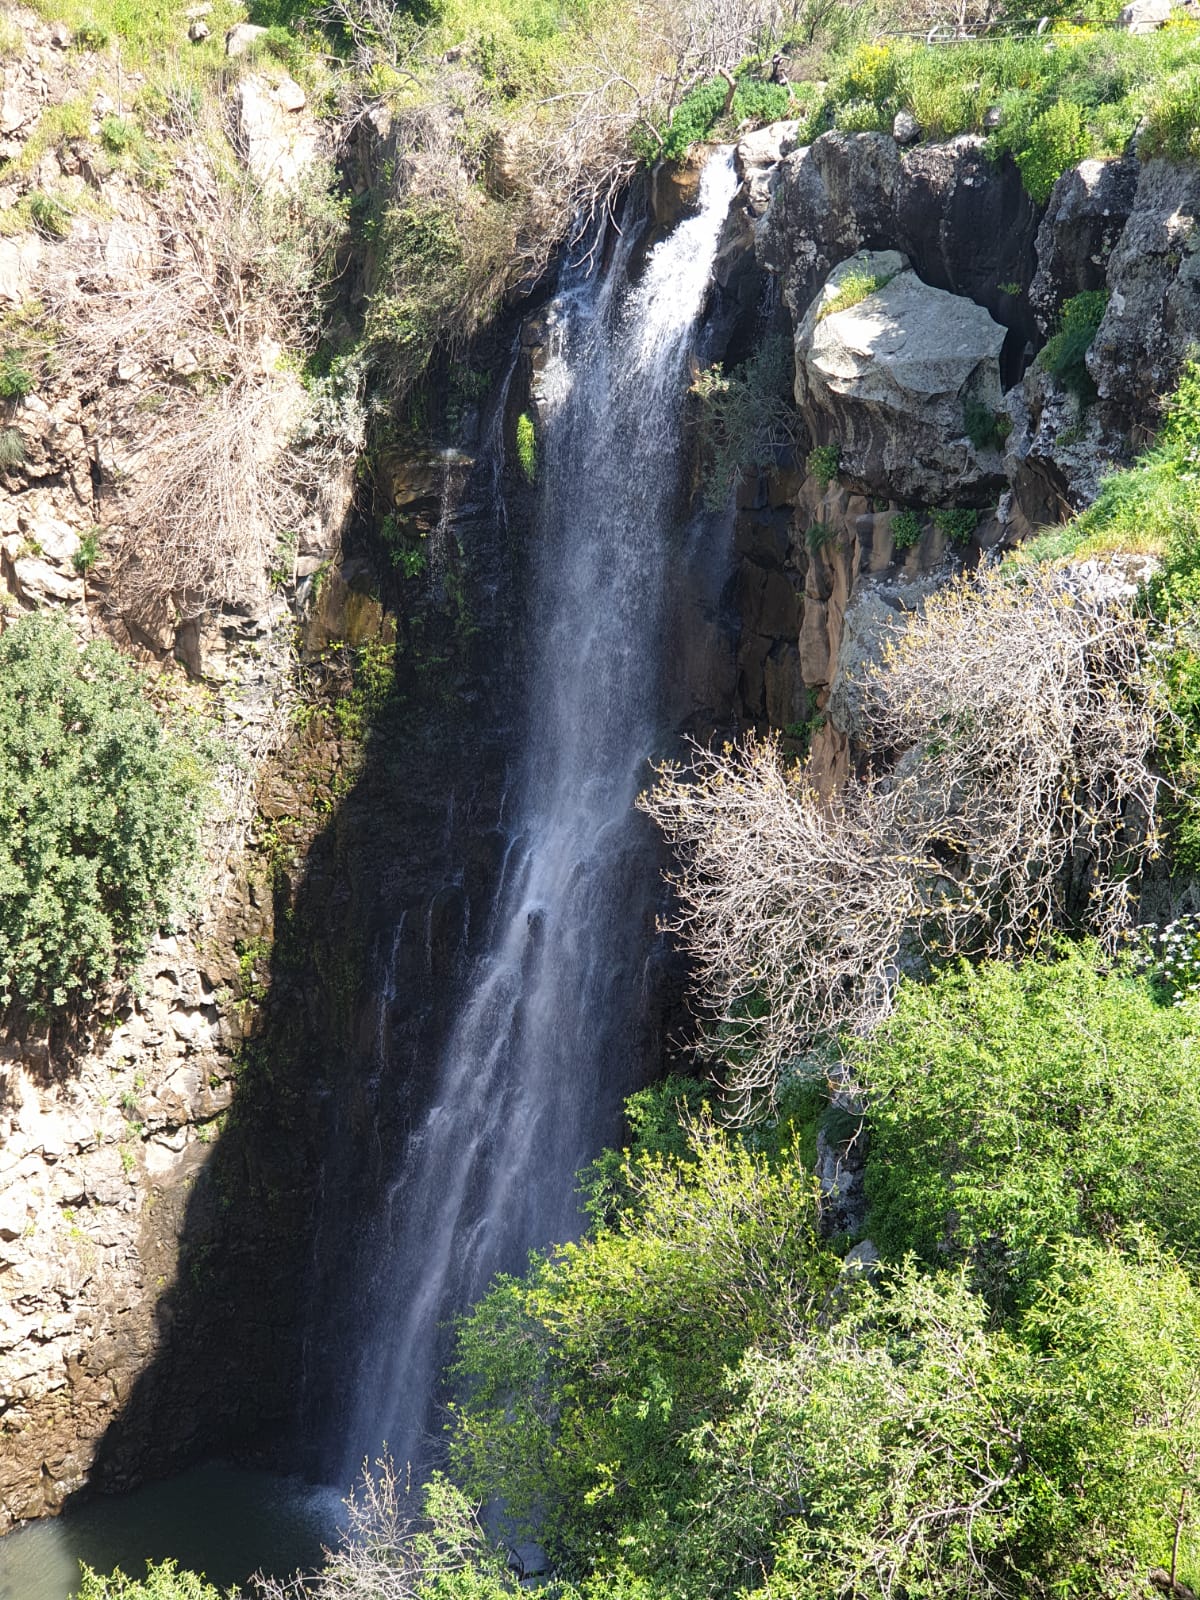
xmin=32 ymin=107 xmax=344 ymax=619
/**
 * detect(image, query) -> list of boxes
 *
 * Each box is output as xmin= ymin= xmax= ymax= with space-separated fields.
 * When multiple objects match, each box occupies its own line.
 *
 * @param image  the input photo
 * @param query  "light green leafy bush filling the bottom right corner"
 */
xmin=681 ymin=1246 xmax=1200 ymax=1600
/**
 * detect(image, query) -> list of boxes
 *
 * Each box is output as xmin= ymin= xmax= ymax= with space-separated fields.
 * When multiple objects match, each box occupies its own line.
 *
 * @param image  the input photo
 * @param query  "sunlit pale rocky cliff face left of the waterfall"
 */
xmin=0 ymin=11 xmax=360 ymax=1531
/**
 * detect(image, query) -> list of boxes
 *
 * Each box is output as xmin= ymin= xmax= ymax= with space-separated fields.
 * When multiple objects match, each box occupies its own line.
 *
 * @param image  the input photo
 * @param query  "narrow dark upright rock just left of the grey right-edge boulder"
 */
xmin=1029 ymin=157 xmax=1139 ymax=334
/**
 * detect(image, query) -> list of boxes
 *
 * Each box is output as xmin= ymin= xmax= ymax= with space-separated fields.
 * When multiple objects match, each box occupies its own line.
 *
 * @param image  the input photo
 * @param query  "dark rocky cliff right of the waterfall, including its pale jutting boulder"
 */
xmin=722 ymin=123 xmax=1200 ymax=787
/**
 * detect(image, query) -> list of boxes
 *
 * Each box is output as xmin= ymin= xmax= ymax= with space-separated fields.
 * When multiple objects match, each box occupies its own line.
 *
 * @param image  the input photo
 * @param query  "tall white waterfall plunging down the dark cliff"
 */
xmin=334 ymin=150 xmax=736 ymax=1480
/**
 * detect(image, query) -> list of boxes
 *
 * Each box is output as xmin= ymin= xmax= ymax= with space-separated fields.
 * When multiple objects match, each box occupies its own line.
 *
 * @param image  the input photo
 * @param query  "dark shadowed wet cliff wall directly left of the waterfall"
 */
xmin=77 ymin=409 xmax=534 ymax=1491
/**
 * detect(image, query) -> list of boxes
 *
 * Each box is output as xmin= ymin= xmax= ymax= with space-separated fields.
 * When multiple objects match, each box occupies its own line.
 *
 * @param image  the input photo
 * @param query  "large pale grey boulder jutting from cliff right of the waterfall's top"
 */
xmin=795 ymin=251 xmax=1005 ymax=506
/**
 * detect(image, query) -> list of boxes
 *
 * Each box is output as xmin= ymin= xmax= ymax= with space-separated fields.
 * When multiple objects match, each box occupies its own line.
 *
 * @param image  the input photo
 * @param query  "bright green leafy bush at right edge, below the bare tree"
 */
xmin=854 ymin=946 xmax=1200 ymax=1302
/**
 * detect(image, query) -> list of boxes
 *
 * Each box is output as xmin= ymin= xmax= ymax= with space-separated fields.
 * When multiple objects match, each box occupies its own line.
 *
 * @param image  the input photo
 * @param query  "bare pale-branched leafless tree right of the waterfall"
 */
xmin=640 ymin=570 xmax=1158 ymax=1118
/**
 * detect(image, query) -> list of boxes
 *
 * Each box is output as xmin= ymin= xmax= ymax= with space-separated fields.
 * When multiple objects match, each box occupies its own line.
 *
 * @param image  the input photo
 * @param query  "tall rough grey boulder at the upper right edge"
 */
xmin=1088 ymin=160 xmax=1200 ymax=426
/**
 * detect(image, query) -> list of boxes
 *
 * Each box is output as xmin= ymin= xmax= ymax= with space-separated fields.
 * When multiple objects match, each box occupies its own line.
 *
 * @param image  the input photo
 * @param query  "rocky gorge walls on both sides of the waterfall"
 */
xmin=0 ymin=19 xmax=1200 ymax=1526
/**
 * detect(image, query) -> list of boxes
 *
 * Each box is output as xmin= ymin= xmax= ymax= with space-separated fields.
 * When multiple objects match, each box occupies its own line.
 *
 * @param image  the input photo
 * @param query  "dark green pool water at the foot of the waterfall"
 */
xmin=0 ymin=1461 xmax=341 ymax=1600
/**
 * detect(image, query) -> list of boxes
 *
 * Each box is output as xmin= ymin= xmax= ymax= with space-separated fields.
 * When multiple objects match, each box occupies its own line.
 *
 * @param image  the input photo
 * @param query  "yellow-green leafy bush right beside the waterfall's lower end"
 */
xmin=453 ymin=1123 xmax=835 ymax=1563
